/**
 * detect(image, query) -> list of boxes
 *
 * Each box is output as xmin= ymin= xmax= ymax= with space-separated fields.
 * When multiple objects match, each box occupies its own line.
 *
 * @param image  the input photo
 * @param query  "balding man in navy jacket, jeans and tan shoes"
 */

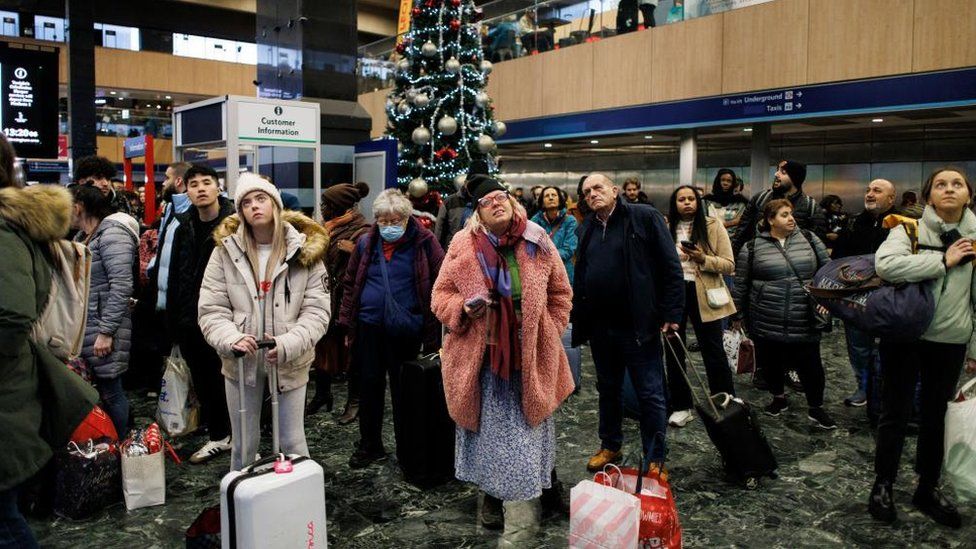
xmin=571 ymin=174 xmax=685 ymax=471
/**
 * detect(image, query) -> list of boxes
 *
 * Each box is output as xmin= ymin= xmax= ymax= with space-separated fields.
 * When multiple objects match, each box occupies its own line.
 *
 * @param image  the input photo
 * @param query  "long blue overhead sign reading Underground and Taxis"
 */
xmin=498 ymin=69 xmax=976 ymax=144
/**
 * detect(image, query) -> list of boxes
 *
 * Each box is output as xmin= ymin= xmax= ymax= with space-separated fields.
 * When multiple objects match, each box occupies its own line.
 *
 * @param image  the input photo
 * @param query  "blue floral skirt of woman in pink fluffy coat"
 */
xmin=454 ymin=367 xmax=556 ymax=501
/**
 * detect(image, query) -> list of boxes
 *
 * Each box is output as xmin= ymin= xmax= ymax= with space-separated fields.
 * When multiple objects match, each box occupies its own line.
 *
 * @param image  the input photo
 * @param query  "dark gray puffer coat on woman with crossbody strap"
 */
xmin=732 ymin=229 xmax=830 ymax=343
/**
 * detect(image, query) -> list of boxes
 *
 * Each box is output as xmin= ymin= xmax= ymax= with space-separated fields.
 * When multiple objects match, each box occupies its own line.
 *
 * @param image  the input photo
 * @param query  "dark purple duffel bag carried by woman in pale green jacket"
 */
xmin=807 ymin=215 xmax=945 ymax=340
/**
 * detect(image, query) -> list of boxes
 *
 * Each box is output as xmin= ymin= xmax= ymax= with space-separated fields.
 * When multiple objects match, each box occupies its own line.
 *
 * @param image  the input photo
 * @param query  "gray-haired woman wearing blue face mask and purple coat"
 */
xmin=339 ymin=189 xmax=444 ymax=469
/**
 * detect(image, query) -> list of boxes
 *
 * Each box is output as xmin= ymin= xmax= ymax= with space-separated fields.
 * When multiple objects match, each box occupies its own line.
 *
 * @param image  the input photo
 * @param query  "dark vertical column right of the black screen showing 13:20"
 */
xmin=64 ymin=0 xmax=96 ymax=161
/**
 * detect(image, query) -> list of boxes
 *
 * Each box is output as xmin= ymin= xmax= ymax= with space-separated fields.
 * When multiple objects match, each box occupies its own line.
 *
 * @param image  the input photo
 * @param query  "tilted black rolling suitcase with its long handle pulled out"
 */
xmin=664 ymin=337 xmax=777 ymax=488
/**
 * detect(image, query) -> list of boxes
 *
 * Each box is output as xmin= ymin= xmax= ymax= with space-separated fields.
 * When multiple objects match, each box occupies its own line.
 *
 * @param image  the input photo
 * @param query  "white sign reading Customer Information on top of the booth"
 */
xmin=237 ymin=101 xmax=320 ymax=146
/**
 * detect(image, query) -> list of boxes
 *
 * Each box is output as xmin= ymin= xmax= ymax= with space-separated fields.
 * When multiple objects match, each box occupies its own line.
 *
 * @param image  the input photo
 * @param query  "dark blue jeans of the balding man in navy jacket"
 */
xmin=590 ymin=330 xmax=668 ymax=462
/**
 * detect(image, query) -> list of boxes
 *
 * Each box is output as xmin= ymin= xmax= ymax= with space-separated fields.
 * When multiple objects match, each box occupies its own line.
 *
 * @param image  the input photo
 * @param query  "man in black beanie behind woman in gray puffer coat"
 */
xmin=732 ymin=160 xmax=827 ymax=257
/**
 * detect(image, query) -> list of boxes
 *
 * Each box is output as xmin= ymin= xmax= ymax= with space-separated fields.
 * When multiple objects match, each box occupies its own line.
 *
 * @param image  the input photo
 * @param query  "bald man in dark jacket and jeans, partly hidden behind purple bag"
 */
xmin=833 ymin=179 xmax=895 ymax=421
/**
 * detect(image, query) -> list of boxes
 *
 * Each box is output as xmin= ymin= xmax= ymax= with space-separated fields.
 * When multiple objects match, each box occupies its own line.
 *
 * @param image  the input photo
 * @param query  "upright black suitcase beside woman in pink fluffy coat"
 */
xmin=393 ymin=353 xmax=455 ymax=487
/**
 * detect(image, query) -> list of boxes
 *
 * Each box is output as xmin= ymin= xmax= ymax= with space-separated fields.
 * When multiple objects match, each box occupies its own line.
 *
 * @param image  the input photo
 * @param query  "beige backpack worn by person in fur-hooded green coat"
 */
xmin=31 ymin=240 xmax=92 ymax=363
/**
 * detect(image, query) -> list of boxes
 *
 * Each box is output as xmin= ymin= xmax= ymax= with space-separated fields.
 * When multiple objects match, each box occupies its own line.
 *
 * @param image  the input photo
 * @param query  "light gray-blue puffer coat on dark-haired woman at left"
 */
xmin=81 ymin=213 xmax=139 ymax=379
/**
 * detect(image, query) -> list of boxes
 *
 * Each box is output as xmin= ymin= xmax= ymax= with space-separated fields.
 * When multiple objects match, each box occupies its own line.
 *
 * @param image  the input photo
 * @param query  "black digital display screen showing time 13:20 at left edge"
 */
xmin=0 ymin=43 xmax=58 ymax=158
